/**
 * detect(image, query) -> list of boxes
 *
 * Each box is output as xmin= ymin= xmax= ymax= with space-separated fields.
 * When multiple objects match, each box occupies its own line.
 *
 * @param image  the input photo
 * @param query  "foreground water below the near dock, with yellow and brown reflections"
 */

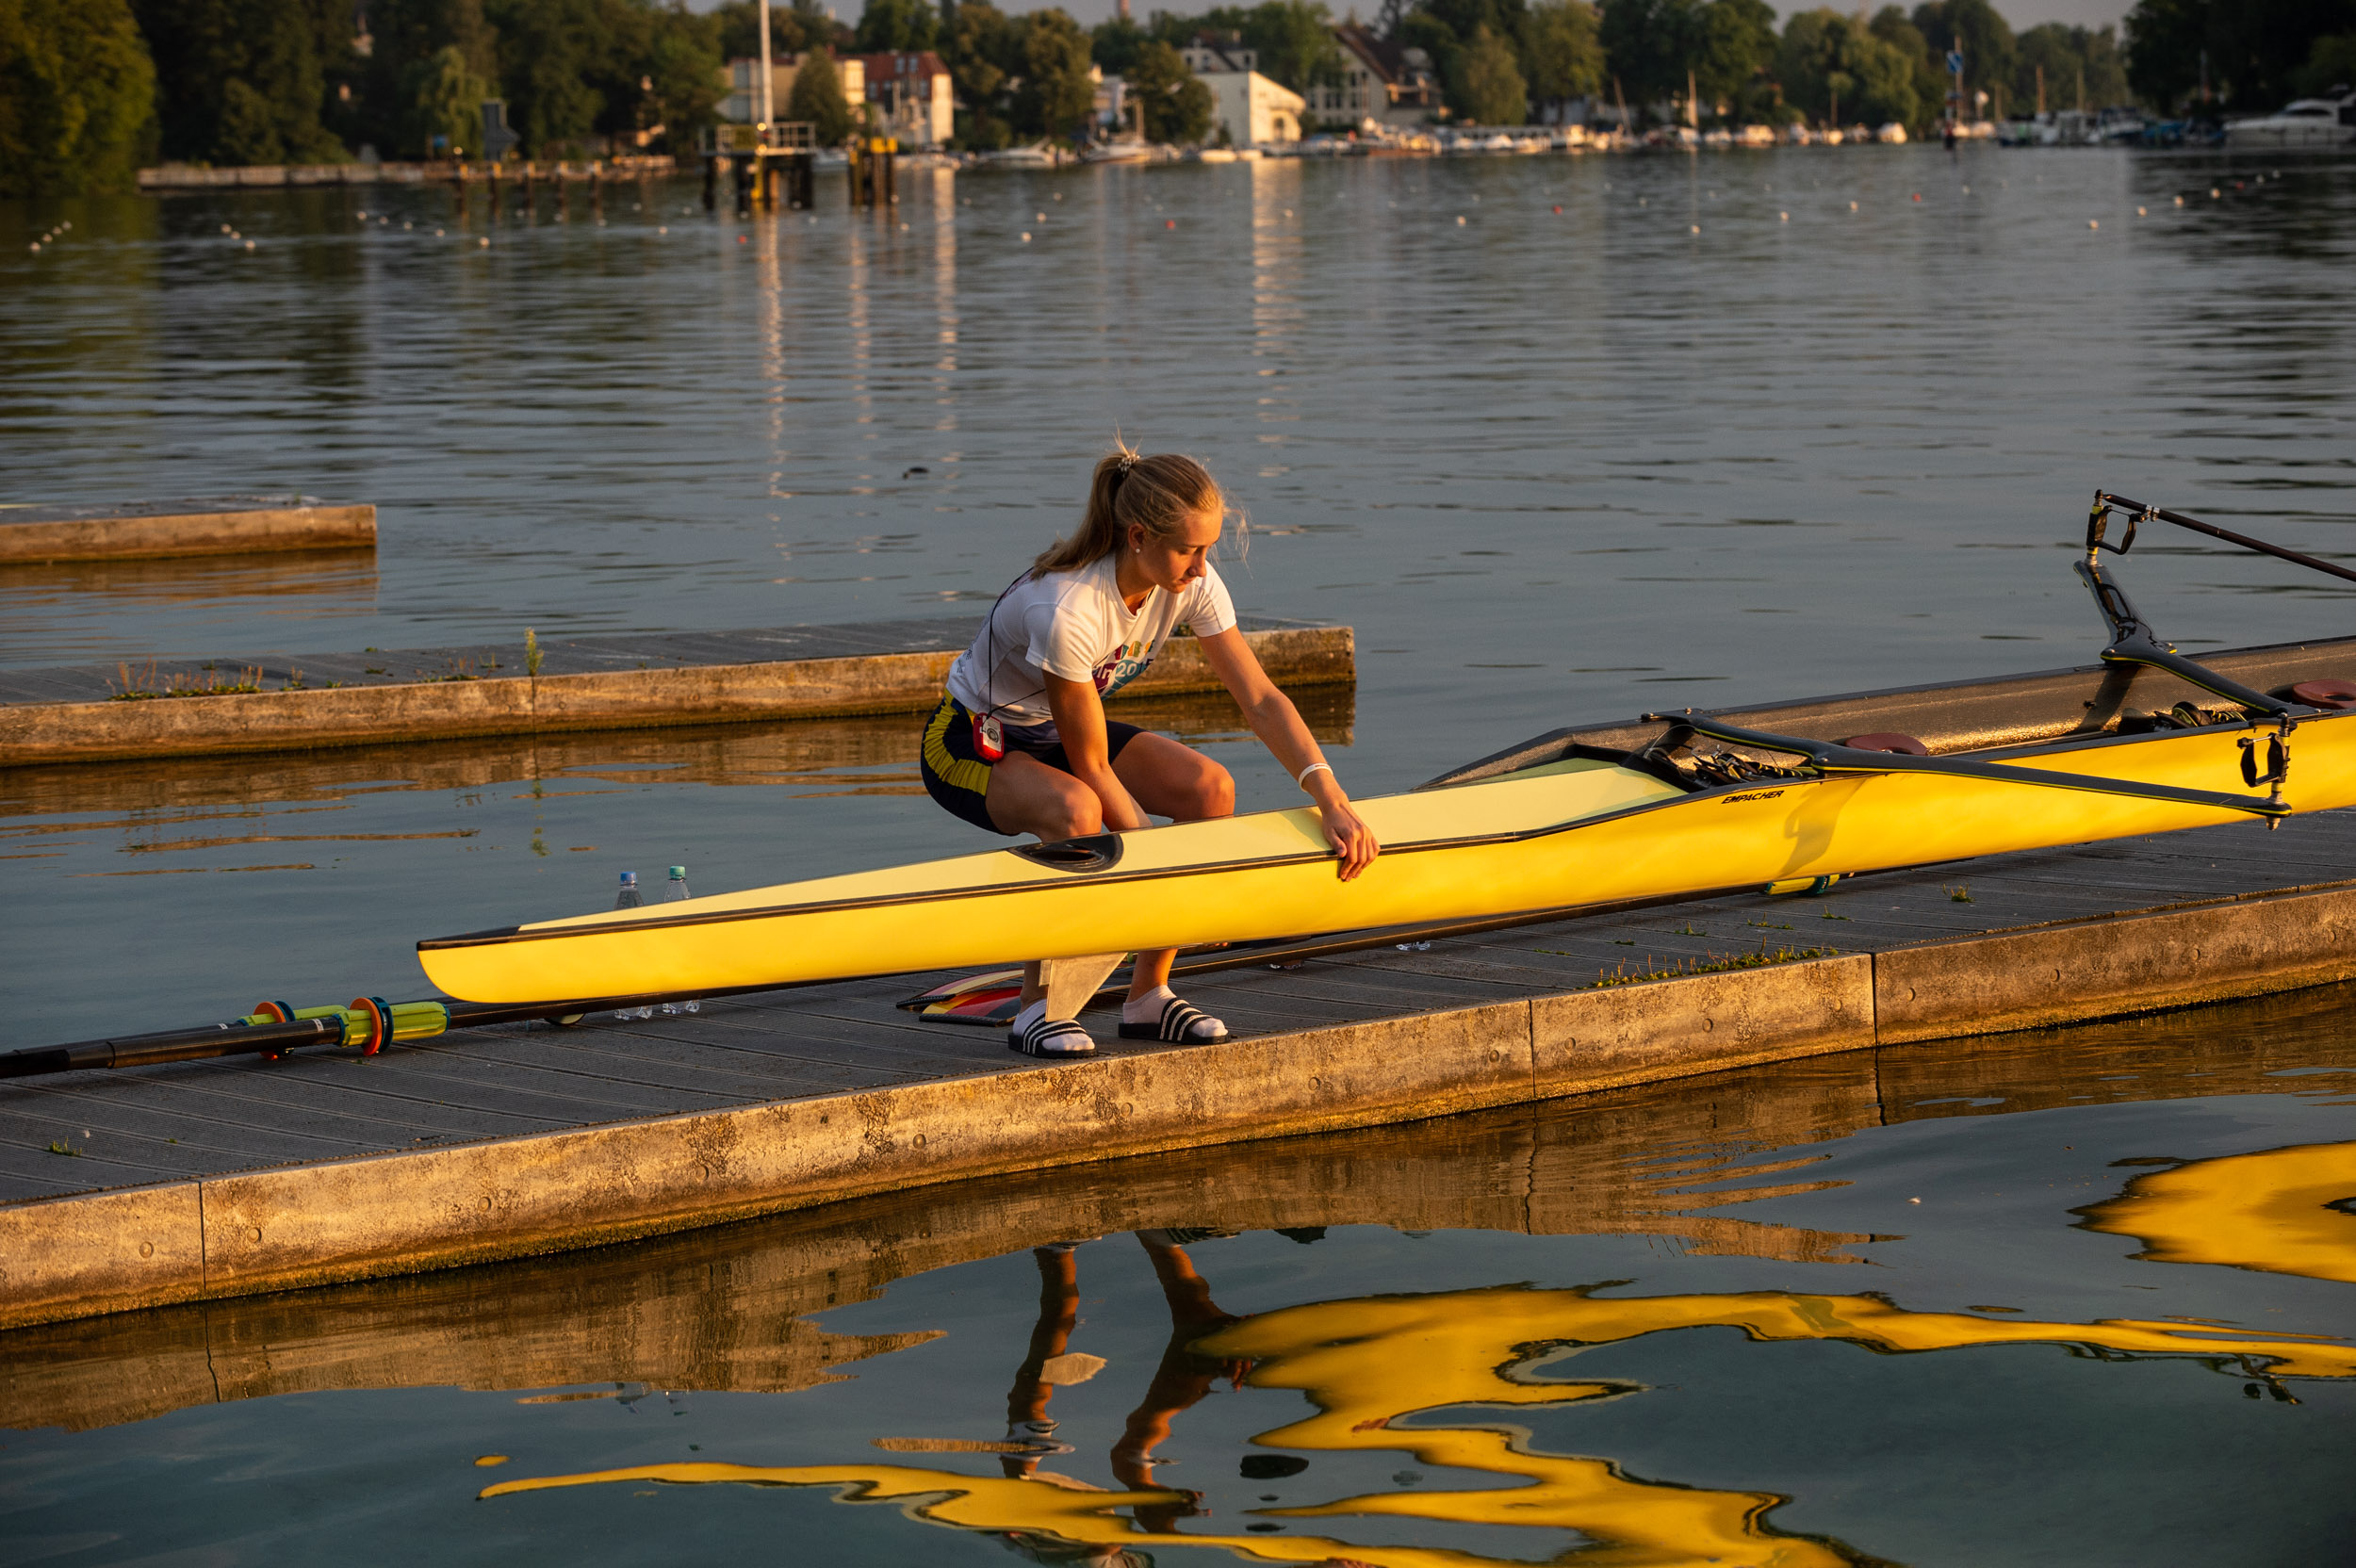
xmin=0 ymin=991 xmax=2356 ymax=1568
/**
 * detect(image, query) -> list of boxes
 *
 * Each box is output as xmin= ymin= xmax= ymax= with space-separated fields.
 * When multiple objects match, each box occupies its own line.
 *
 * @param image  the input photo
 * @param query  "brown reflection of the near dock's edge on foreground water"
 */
xmin=0 ymin=991 xmax=2356 ymax=1431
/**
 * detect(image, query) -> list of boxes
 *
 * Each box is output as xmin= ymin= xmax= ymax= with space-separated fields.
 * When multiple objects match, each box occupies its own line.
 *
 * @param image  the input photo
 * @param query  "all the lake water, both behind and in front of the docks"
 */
xmin=0 ymin=148 xmax=2356 ymax=1568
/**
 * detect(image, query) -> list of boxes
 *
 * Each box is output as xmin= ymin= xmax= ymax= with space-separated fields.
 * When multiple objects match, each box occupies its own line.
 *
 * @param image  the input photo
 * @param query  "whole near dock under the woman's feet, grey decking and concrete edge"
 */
xmin=0 ymin=795 xmax=2356 ymax=1328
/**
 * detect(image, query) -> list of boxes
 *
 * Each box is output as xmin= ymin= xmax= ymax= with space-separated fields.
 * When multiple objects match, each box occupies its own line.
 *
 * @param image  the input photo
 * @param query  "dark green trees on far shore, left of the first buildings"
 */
xmin=0 ymin=0 xmax=724 ymax=193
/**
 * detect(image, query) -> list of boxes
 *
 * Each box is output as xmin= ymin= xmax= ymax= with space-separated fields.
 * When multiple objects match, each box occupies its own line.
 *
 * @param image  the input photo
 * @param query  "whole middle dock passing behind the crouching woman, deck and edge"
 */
xmin=0 ymin=617 xmax=1357 ymax=768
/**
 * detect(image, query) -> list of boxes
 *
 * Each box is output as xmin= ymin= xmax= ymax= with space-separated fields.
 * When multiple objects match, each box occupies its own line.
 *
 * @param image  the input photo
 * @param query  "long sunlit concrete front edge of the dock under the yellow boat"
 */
xmin=0 ymin=871 xmax=2356 ymax=1328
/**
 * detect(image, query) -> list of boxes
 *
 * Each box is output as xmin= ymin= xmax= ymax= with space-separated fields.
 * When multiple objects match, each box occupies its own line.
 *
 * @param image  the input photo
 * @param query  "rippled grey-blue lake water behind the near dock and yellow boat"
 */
xmin=0 ymin=148 xmax=2356 ymax=1045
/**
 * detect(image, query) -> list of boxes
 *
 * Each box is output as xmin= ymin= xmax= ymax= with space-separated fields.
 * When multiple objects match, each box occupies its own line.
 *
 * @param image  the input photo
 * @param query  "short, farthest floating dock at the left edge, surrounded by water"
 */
xmin=0 ymin=495 xmax=377 ymax=565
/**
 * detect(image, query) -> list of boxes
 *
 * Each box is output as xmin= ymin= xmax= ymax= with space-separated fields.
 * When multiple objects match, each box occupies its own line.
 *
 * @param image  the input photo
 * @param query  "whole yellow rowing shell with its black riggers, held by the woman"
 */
xmin=419 ymin=497 xmax=2356 ymax=1005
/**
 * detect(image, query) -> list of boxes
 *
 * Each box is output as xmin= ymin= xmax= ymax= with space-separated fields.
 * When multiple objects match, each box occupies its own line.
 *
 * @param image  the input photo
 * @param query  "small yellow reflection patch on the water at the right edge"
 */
xmin=2078 ymin=1144 xmax=2356 ymax=1285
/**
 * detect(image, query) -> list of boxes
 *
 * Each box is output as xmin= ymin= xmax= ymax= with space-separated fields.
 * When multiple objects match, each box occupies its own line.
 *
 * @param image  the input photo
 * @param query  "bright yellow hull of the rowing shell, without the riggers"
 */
xmin=419 ymin=713 xmax=2356 ymax=1005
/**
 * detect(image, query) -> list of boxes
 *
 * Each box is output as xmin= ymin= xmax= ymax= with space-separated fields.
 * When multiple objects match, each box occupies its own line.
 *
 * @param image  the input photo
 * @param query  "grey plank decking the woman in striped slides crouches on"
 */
xmin=0 ymin=809 xmax=2356 ymax=1203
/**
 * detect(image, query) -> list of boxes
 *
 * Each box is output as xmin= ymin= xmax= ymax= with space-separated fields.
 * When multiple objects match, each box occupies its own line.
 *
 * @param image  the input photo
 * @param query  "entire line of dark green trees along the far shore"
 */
xmin=0 ymin=0 xmax=2356 ymax=193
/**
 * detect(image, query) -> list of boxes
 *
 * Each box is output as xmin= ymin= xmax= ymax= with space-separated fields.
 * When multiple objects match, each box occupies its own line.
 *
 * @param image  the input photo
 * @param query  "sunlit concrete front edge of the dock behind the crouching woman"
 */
xmin=0 ymin=627 xmax=1357 ymax=768
